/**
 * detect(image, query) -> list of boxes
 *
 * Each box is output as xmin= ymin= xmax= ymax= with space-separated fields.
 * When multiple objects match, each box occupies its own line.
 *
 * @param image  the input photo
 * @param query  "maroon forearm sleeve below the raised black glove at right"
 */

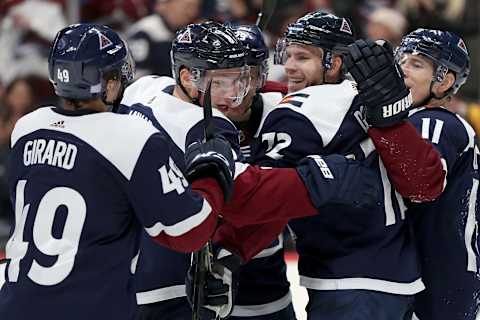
xmin=368 ymin=121 xmax=446 ymax=202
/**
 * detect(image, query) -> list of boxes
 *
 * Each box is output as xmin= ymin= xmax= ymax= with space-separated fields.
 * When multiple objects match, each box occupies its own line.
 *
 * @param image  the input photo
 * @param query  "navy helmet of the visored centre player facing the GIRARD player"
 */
xmin=170 ymin=21 xmax=247 ymax=83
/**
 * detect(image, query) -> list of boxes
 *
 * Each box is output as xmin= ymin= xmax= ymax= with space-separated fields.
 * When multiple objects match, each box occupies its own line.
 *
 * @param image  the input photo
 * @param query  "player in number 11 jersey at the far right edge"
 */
xmin=396 ymin=29 xmax=480 ymax=320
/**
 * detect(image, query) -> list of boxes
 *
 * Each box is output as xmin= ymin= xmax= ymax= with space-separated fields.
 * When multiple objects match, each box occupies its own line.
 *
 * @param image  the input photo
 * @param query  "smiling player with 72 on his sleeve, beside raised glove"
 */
xmin=255 ymin=12 xmax=444 ymax=320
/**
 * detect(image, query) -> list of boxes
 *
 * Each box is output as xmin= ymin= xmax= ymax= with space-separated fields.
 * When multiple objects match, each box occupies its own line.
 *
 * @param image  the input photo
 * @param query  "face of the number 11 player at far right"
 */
xmin=398 ymin=53 xmax=434 ymax=105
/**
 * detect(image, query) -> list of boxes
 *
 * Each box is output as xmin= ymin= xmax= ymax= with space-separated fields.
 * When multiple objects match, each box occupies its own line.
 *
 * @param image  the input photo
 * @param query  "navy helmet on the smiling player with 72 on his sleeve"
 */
xmin=275 ymin=11 xmax=355 ymax=69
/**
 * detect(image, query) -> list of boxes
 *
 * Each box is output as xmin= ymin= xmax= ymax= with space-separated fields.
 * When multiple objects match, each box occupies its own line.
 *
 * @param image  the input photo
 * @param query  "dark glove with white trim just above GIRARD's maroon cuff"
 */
xmin=185 ymin=136 xmax=235 ymax=201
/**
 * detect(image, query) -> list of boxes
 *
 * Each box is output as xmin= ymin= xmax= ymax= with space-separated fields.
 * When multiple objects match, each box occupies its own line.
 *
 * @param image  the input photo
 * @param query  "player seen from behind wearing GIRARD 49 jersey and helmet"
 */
xmin=0 ymin=24 xmax=238 ymax=320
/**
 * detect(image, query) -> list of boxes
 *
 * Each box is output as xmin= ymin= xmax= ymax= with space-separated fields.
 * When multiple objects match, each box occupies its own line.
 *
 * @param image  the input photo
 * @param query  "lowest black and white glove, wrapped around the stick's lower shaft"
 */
xmin=185 ymin=248 xmax=241 ymax=320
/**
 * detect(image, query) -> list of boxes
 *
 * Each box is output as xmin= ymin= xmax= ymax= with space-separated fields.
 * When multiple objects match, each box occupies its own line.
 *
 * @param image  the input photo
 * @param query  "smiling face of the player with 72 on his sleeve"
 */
xmin=285 ymin=43 xmax=323 ymax=92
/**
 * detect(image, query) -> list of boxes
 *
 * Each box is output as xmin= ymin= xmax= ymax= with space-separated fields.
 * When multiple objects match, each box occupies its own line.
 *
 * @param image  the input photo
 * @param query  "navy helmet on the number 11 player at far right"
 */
xmin=396 ymin=29 xmax=470 ymax=94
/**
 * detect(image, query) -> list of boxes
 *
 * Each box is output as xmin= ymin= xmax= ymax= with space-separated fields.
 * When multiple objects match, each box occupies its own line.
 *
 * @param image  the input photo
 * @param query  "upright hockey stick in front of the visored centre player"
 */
xmin=192 ymin=80 xmax=214 ymax=320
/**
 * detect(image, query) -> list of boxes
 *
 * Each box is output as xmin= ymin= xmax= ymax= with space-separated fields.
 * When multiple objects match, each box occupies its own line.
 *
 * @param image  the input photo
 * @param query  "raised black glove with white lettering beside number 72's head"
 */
xmin=343 ymin=39 xmax=412 ymax=127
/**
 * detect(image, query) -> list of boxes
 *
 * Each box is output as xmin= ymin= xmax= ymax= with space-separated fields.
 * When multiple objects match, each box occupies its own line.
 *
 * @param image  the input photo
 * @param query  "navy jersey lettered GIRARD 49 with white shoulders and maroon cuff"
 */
xmin=0 ymin=107 xmax=219 ymax=320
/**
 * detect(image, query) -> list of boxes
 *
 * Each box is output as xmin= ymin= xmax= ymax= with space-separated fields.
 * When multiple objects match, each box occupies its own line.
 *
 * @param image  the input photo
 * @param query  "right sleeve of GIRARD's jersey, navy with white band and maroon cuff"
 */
xmin=127 ymin=133 xmax=223 ymax=252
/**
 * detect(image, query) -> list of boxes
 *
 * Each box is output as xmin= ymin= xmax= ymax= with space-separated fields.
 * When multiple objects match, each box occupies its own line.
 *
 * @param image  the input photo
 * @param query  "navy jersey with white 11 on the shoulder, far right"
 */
xmin=407 ymin=108 xmax=480 ymax=320
